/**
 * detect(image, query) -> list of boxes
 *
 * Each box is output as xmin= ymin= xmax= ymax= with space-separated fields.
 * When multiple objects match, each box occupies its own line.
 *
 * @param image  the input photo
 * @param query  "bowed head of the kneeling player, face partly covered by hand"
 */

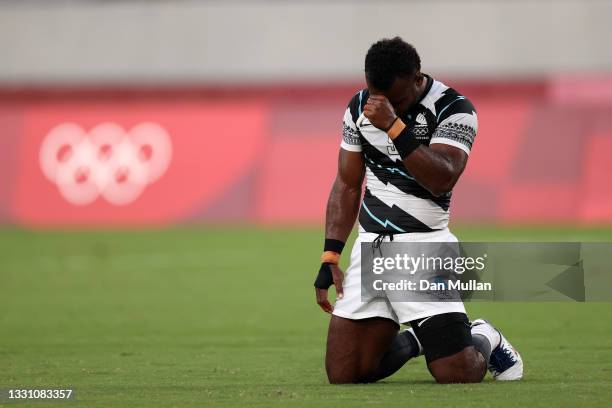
xmin=365 ymin=37 xmax=424 ymax=114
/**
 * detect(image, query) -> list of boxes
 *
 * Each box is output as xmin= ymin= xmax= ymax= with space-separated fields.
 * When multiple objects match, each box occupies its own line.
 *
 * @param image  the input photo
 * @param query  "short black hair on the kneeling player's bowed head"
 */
xmin=365 ymin=37 xmax=421 ymax=91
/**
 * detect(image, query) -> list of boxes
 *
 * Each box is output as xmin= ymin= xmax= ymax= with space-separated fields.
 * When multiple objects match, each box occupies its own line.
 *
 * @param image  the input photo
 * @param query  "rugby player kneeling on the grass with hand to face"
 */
xmin=315 ymin=37 xmax=523 ymax=383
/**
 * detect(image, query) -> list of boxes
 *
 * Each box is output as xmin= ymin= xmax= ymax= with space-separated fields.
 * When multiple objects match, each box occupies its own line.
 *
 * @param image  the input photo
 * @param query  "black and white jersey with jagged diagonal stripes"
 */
xmin=341 ymin=76 xmax=478 ymax=233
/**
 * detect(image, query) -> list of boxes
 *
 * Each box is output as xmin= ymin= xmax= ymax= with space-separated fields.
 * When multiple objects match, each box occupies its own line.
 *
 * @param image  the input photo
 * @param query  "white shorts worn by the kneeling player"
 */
xmin=333 ymin=228 xmax=465 ymax=323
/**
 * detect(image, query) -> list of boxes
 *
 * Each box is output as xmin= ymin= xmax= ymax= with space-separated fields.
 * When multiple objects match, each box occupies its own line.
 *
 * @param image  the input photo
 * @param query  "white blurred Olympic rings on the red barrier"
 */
xmin=39 ymin=122 xmax=172 ymax=205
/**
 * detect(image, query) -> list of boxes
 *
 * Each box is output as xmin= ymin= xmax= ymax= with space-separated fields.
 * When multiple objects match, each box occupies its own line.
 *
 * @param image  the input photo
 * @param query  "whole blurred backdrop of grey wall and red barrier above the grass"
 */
xmin=0 ymin=0 xmax=612 ymax=227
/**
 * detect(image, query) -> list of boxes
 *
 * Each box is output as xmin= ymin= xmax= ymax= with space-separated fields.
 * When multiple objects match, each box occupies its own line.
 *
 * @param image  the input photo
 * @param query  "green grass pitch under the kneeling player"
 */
xmin=0 ymin=226 xmax=612 ymax=407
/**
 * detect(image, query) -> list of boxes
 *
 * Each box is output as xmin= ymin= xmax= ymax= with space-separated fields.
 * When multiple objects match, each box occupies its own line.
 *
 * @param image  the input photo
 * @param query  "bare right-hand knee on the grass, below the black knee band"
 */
xmin=428 ymin=347 xmax=487 ymax=384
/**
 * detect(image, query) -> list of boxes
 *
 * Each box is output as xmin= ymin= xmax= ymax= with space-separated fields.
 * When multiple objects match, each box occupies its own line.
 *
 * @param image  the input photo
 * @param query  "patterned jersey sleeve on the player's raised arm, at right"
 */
xmin=429 ymin=97 xmax=478 ymax=155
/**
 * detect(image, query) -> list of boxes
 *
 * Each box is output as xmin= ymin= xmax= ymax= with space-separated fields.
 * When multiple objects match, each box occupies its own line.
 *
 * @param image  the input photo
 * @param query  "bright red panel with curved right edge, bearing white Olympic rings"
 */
xmin=6 ymin=102 xmax=267 ymax=225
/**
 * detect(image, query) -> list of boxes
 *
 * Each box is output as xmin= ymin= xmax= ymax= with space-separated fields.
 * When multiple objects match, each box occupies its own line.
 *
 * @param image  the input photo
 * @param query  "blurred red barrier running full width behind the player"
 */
xmin=0 ymin=76 xmax=612 ymax=227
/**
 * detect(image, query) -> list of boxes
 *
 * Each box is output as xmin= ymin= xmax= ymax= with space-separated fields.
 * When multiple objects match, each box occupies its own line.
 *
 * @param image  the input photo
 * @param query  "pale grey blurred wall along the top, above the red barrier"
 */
xmin=0 ymin=0 xmax=612 ymax=85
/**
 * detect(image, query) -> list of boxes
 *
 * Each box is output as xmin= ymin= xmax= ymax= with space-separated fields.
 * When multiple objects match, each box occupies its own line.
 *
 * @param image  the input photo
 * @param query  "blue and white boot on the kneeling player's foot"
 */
xmin=472 ymin=319 xmax=523 ymax=381
